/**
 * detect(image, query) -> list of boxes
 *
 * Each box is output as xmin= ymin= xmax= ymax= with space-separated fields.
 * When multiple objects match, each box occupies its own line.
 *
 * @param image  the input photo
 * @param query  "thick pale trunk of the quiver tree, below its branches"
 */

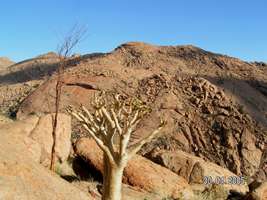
xmin=102 ymin=156 xmax=124 ymax=200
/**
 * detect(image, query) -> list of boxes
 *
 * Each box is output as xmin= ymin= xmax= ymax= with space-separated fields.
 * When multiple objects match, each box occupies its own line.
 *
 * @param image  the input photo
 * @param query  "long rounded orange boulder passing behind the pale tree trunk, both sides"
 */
xmin=75 ymin=138 xmax=192 ymax=199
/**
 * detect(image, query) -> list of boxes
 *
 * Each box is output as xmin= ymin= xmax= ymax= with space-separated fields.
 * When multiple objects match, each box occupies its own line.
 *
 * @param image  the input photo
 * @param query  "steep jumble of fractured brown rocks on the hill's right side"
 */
xmin=142 ymin=78 xmax=267 ymax=176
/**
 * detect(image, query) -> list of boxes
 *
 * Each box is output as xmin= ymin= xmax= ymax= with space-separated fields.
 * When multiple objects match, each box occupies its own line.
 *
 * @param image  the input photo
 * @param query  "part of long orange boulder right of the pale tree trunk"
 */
xmin=123 ymin=155 xmax=193 ymax=198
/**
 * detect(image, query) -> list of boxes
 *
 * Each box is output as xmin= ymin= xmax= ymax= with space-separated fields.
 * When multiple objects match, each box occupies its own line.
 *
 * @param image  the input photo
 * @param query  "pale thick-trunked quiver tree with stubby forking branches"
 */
xmin=68 ymin=92 xmax=166 ymax=200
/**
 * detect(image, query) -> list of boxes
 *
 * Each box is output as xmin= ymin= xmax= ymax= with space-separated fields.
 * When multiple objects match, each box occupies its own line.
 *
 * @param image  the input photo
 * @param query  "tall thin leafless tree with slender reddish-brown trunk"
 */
xmin=50 ymin=25 xmax=87 ymax=171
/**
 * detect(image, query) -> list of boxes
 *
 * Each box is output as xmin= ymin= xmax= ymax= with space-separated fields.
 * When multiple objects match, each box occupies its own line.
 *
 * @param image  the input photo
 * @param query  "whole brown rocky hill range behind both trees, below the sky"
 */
xmin=0 ymin=42 xmax=267 ymax=198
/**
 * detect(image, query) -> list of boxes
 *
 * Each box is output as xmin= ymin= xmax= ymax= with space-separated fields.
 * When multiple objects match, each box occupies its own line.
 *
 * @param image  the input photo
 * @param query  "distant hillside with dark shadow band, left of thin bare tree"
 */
xmin=0 ymin=52 xmax=58 ymax=116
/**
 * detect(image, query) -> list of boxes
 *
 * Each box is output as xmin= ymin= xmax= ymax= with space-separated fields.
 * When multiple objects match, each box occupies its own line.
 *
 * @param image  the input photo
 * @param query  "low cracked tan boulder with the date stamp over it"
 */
xmin=151 ymin=151 xmax=248 ymax=194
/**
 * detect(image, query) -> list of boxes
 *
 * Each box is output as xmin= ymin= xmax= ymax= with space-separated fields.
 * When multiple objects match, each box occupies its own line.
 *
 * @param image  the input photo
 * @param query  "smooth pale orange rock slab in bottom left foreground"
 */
xmin=0 ymin=118 xmax=92 ymax=200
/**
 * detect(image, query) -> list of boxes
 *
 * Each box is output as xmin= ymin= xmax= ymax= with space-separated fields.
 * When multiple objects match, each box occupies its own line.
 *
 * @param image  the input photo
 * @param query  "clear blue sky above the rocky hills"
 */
xmin=0 ymin=0 xmax=267 ymax=61
